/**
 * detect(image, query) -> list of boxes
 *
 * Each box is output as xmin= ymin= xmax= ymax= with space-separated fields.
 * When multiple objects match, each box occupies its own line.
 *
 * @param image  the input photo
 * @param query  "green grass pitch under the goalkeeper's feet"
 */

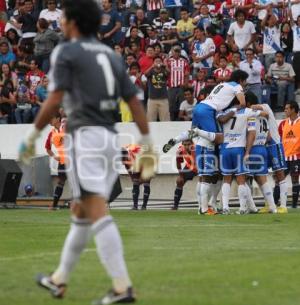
xmin=0 ymin=210 xmax=300 ymax=305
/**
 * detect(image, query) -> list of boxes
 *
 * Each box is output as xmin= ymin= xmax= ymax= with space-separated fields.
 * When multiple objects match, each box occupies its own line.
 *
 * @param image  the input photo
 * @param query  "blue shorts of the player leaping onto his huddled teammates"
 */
xmin=192 ymin=103 xmax=219 ymax=132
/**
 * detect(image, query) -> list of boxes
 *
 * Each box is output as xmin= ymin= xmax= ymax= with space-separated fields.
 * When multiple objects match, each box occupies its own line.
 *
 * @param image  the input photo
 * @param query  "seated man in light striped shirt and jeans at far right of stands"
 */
xmin=267 ymin=51 xmax=295 ymax=111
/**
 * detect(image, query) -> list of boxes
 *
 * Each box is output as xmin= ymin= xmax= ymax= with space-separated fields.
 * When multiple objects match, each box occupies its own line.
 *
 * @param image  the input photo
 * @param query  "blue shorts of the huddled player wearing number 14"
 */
xmin=248 ymin=145 xmax=268 ymax=176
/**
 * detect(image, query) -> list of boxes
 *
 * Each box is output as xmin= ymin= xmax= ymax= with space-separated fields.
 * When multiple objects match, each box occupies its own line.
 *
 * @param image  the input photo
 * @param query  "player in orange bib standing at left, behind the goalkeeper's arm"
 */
xmin=45 ymin=113 xmax=67 ymax=210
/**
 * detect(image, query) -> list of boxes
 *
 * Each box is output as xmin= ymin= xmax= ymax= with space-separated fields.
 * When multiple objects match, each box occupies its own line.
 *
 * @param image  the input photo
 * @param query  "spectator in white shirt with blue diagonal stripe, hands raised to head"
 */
xmin=261 ymin=7 xmax=281 ymax=71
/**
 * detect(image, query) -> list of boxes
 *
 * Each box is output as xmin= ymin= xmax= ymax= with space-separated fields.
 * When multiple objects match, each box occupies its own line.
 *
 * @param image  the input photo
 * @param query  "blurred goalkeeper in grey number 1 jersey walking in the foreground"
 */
xmin=20 ymin=0 xmax=156 ymax=304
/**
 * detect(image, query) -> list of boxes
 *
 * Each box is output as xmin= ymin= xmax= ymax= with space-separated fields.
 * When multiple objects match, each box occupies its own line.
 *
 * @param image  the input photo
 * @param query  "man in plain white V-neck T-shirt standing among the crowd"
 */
xmin=228 ymin=10 xmax=256 ymax=53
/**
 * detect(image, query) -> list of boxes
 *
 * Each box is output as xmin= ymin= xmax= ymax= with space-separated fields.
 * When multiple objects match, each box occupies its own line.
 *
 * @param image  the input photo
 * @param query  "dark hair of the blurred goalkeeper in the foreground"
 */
xmin=63 ymin=0 xmax=101 ymax=36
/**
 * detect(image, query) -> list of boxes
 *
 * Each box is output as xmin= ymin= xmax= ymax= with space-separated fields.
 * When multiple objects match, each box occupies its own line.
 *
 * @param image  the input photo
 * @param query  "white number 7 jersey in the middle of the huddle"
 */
xmin=217 ymin=108 xmax=260 ymax=148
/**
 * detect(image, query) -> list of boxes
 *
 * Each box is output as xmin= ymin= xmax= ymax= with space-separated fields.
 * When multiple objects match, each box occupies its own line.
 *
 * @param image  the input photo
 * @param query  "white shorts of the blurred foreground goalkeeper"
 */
xmin=64 ymin=126 xmax=120 ymax=199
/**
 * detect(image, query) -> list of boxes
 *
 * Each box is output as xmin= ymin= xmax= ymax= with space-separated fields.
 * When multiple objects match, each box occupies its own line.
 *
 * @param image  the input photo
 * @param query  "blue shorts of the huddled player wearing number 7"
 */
xmin=220 ymin=144 xmax=249 ymax=176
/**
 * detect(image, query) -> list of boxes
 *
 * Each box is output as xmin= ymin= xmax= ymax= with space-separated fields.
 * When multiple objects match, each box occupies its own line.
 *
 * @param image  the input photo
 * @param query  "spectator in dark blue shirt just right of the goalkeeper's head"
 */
xmin=100 ymin=0 xmax=122 ymax=47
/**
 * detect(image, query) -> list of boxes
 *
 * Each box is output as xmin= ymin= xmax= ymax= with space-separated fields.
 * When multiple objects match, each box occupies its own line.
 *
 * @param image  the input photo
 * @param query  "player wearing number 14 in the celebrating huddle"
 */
xmin=246 ymin=92 xmax=277 ymax=213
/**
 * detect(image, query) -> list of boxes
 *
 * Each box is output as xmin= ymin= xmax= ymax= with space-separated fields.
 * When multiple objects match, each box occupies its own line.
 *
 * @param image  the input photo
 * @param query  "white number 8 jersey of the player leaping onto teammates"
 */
xmin=202 ymin=82 xmax=243 ymax=111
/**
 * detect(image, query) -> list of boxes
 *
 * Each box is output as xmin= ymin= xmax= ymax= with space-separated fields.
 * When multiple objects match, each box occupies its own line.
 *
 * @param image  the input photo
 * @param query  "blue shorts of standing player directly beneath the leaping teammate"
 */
xmin=196 ymin=145 xmax=218 ymax=176
